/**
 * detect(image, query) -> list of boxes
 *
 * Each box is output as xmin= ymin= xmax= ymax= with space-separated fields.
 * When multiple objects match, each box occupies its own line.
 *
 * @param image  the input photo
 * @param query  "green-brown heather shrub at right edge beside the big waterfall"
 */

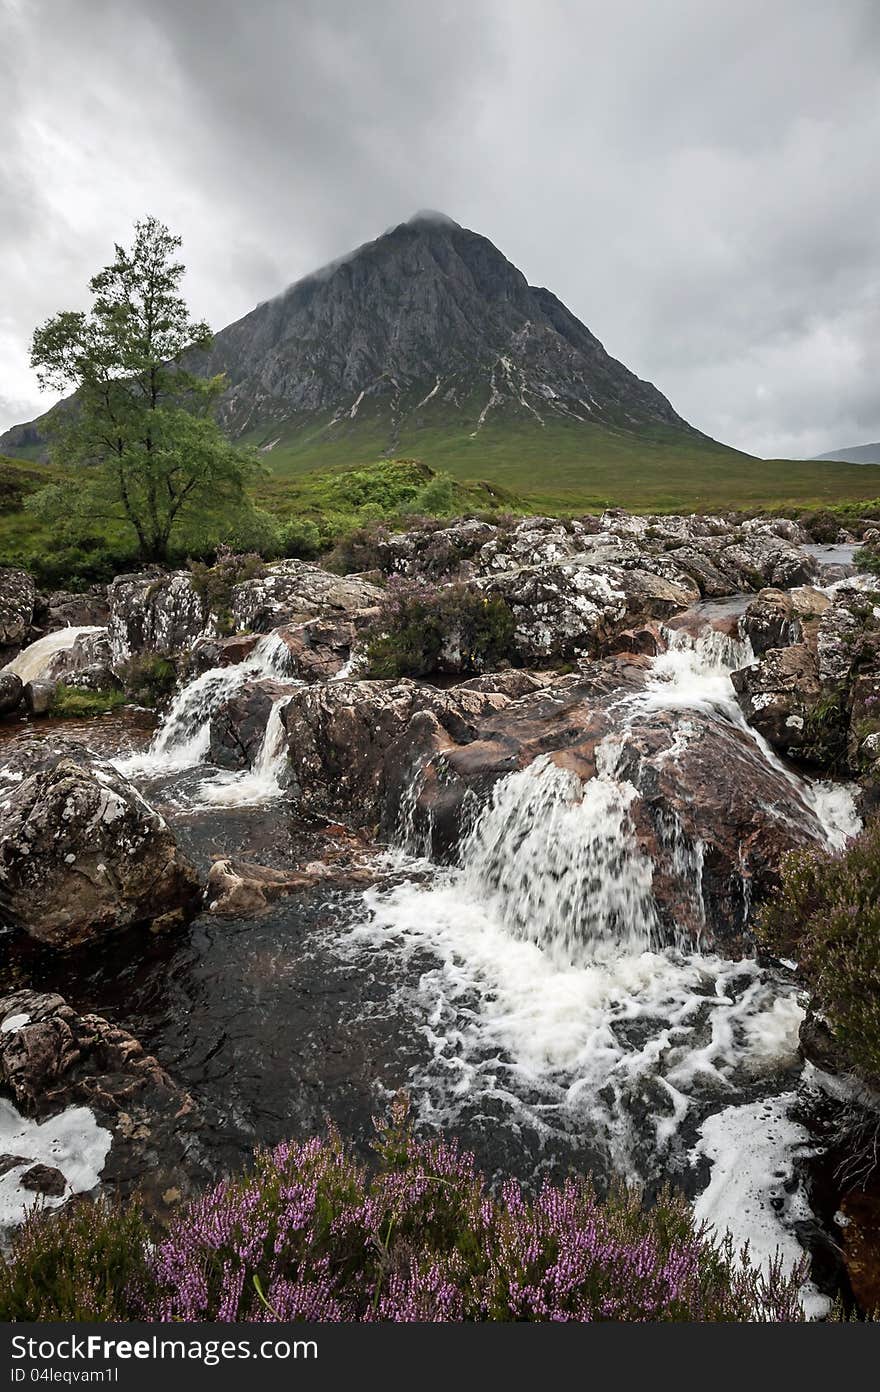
xmin=757 ymin=821 xmax=880 ymax=1083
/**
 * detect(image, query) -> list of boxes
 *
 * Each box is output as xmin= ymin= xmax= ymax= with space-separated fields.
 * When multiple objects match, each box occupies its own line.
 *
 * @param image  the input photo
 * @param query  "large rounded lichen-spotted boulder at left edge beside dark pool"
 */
xmin=0 ymin=753 xmax=199 ymax=948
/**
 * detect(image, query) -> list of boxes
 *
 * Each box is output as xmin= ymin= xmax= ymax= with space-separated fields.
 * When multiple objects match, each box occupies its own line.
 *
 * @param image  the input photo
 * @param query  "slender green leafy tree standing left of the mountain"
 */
xmin=31 ymin=217 xmax=258 ymax=561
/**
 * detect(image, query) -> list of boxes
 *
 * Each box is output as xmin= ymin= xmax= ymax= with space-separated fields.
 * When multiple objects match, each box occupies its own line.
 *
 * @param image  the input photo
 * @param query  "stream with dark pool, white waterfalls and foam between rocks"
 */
xmin=0 ymin=599 xmax=858 ymax=1313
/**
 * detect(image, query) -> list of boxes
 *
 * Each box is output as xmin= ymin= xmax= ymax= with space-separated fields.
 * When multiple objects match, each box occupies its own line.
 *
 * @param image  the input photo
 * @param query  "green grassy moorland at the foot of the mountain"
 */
xmin=0 ymin=437 xmax=880 ymax=590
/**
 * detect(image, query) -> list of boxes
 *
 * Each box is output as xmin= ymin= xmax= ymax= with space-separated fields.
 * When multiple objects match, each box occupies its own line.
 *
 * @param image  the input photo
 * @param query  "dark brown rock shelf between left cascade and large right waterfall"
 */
xmin=281 ymin=681 xmax=510 ymax=827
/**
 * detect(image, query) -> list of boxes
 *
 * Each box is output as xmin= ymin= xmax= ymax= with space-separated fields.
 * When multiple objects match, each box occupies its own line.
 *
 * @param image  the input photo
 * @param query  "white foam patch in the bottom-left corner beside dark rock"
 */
xmin=0 ymin=1098 xmax=113 ymax=1228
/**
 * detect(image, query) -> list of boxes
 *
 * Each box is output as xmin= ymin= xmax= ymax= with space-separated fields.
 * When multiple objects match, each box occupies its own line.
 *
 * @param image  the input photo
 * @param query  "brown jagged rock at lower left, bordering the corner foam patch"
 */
xmin=0 ymin=990 xmax=207 ymax=1214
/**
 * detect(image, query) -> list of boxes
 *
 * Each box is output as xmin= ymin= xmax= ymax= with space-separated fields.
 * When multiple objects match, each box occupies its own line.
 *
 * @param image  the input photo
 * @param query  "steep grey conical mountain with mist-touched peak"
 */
xmin=0 ymin=213 xmax=744 ymax=482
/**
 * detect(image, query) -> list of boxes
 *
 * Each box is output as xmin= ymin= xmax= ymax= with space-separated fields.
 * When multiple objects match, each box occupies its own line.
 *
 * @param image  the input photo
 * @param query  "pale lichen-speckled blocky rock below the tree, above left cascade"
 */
xmin=107 ymin=571 xmax=210 ymax=665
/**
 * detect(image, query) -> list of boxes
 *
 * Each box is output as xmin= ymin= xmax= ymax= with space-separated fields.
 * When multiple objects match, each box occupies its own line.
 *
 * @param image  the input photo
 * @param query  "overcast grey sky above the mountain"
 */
xmin=0 ymin=0 xmax=880 ymax=457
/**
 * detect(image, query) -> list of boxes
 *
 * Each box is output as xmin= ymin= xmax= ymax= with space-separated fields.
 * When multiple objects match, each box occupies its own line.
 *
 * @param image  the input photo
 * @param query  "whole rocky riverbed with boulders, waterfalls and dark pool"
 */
xmin=0 ymin=511 xmax=880 ymax=1313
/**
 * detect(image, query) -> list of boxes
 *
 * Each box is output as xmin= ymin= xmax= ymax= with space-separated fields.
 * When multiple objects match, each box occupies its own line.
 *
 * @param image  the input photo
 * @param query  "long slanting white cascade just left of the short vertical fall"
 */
xmin=117 ymin=633 xmax=290 ymax=778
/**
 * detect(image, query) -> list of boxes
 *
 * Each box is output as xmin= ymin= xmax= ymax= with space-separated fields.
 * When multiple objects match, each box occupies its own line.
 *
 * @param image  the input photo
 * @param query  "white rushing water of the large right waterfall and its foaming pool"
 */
xmin=340 ymin=618 xmax=859 ymax=1308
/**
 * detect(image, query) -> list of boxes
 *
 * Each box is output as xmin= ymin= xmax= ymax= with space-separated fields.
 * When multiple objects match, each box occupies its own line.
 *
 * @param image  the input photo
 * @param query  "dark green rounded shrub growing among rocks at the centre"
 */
xmin=366 ymin=578 xmax=515 ymax=678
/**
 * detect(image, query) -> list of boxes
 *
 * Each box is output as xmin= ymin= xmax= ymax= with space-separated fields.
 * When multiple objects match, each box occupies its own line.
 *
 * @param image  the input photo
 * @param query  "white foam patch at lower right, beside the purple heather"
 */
xmin=693 ymin=1093 xmax=831 ymax=1318
